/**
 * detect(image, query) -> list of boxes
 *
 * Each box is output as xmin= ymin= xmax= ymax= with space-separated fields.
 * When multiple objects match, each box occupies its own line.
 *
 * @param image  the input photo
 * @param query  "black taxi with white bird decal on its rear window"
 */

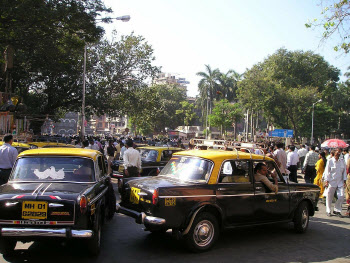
xmin=0 ymin=148 xmax=116 ymax=255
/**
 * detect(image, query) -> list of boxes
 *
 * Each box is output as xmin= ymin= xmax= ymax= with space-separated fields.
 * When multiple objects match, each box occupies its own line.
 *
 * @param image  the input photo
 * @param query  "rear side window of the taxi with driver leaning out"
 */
xmin=219 ymin=160 xmax=251 ymax=183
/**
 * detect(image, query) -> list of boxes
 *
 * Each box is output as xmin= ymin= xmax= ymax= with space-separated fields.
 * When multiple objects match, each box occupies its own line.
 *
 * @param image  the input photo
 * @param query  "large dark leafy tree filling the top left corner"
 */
xmin=0 ymin=0 xmax=112 ymax=133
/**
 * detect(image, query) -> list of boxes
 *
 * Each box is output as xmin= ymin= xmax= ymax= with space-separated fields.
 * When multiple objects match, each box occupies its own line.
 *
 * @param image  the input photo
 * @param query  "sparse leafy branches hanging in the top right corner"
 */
xmin=305 ymin=0 xmax=350 ymax=53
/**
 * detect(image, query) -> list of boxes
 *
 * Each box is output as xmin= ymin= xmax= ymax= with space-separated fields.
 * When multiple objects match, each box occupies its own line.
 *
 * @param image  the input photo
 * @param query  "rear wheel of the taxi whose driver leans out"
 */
xmin=185 ymin=212 xmax=219 ymax=252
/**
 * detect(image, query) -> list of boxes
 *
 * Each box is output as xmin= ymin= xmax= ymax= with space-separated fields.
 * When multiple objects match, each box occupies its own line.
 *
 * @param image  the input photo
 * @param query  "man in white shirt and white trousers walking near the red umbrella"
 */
xmin=324 ymin=152 xmax=347 ymax=217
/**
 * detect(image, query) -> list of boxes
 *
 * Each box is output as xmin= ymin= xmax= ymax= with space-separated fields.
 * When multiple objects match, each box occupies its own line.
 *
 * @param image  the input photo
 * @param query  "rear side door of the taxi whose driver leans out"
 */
xmin=216 ymin=160 xmax=254 ymax=225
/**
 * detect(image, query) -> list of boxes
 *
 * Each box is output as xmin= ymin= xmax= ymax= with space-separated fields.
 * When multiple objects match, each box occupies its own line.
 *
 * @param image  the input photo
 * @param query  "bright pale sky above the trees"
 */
xmin=100 ymin=0 xmax=350 ymax=97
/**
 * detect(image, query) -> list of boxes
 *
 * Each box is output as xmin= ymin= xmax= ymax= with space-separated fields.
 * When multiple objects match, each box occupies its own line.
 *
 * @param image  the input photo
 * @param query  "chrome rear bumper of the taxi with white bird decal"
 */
xmin=1 ymin=227 xmax=93 ymax=238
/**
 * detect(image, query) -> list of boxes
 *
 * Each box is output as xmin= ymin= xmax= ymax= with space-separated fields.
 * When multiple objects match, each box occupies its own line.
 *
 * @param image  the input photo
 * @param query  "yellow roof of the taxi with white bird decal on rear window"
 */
xmin=18 ymin=147 xmax=101 ymax=160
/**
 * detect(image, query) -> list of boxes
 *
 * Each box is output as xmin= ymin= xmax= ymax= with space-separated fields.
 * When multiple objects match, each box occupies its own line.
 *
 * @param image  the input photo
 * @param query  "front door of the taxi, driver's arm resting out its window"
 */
xmin=253 ymin=161 xmax=290 ymax=222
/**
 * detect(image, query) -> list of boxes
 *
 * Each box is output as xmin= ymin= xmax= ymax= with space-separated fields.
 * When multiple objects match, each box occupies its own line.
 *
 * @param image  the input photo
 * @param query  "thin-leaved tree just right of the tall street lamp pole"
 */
xmin=86 ymin=32 xmax=159 ymax=115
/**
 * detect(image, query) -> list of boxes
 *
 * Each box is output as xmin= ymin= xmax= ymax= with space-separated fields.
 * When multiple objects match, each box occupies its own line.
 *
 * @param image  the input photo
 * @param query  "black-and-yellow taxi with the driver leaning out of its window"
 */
xmin=117 ymin=150 xmax=320 ymax=251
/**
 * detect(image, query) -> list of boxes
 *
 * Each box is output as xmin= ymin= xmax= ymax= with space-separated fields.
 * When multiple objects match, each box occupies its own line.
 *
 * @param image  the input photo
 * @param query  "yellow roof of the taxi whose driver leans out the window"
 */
xmin=174 ymin=150 xmax=273 ymax=161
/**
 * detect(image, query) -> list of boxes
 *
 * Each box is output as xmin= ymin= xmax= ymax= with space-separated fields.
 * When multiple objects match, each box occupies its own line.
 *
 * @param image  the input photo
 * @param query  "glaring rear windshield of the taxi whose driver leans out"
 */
xmin=159 ymin=156 xmax=213 ymax=183
